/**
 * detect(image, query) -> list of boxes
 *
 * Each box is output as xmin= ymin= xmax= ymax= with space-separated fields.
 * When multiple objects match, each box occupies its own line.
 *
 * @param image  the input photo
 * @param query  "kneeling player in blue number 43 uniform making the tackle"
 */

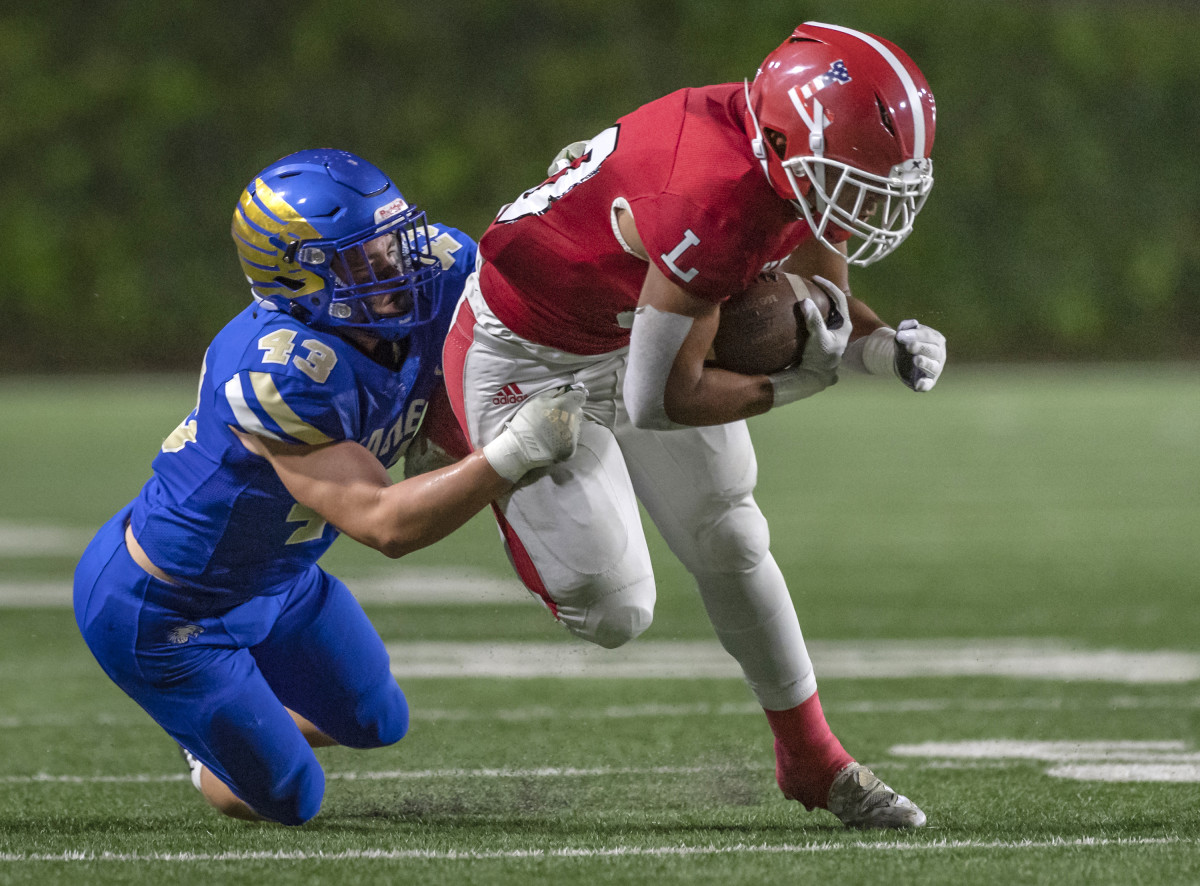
xmin=74 ymin=150 xmax=584 ymax=825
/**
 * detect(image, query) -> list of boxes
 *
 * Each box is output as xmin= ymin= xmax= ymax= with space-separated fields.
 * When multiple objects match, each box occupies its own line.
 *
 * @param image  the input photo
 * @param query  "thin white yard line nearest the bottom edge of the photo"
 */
xmin=0 ymin=834 xmax=1198 ymax=863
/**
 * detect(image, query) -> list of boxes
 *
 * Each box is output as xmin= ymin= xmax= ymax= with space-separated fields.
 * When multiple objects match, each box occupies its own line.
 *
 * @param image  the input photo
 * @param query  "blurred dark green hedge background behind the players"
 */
xmin=0 ymin=0 xmax=1200 ymax=373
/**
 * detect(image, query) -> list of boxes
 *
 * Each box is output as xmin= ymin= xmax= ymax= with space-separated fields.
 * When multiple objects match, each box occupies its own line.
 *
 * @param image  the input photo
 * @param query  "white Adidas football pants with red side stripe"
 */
xmin=445 ymin=277 xmax=816 ymax=710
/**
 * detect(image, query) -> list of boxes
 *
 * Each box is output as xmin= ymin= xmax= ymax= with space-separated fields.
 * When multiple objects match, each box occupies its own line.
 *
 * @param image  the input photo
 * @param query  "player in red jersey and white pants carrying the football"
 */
xmin=444 ymin=23 xmax=946 ymax=827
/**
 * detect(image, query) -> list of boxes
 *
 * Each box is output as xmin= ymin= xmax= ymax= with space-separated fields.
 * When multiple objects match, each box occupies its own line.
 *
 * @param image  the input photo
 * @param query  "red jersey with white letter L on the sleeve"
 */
xmin=479 ymin=83 xmax=809 ymax=354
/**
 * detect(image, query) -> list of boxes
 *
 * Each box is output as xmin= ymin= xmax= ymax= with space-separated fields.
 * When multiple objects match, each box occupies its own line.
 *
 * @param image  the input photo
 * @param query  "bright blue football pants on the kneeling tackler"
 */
xmin=74 ymin=511 xmax=408 ymax=825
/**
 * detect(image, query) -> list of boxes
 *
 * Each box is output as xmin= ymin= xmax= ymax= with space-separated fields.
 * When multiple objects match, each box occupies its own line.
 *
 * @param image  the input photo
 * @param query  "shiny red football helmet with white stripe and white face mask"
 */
xmin=746 ymin=22 xmax=937 ymax=265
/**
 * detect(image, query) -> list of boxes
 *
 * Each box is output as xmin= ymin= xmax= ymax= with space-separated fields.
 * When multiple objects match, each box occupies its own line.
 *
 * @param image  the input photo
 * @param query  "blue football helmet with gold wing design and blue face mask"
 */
xmin=233 ymin=149 xmax=442 ymax=341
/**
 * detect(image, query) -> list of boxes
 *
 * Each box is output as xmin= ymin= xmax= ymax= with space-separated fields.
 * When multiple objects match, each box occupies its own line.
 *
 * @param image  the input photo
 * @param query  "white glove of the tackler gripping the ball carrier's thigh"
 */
xmin=484 ymin=384 xmax=588 ymax=483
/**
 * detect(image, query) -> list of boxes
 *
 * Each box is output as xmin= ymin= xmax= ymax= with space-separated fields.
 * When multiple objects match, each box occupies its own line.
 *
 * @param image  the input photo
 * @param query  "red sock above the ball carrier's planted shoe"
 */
xmin=766 ymin=693 xmax=854 ymax=809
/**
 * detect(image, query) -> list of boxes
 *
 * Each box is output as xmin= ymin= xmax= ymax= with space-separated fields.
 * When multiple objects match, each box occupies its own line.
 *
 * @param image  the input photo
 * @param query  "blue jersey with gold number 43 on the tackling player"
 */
xmin=130 ymin=225 xmax=475 ymax=606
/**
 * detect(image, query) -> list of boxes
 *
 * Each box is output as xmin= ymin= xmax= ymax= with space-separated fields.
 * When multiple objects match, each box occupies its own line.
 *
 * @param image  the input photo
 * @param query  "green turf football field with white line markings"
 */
xmin=0 ymin=365 xmax=1200 ymax=886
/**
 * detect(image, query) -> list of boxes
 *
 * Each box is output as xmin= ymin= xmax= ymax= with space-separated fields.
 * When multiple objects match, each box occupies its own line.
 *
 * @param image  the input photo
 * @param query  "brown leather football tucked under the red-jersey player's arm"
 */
xmin=709 ymin=271 xmax=841 ymax=376
